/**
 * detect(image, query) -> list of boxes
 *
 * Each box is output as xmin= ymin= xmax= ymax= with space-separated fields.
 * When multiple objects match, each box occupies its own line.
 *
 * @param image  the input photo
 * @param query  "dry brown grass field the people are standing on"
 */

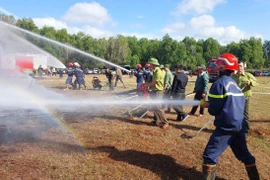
xmin=0 ymin=75 xmax=270 ymax=180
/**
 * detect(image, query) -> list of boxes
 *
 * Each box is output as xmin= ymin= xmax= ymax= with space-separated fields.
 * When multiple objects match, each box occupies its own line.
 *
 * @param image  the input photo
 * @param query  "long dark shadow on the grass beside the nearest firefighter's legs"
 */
xmin=89 ymin=146 xmax=226 ymax=180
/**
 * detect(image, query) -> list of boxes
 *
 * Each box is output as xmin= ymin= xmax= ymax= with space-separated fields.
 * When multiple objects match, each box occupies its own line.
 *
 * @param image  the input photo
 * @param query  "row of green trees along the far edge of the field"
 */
xmin=0 ymin=14 xmax=270 ymax=70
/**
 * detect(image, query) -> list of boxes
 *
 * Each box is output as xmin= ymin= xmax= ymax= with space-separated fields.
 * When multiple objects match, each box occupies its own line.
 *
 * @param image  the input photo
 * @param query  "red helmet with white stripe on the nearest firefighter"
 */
xmin=216 ymin=53 xmax=238 ymax=71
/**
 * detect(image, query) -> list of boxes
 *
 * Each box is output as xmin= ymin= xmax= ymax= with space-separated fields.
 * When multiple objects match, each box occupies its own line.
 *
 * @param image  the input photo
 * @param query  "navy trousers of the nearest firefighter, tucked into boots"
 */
xmin=203 ymin=129 xmax=255 ymax=165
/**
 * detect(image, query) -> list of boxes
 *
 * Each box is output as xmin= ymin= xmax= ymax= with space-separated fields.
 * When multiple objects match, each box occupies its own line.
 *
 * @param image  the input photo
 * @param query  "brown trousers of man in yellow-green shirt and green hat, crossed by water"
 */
xmin=150 ymin=91 xmax=168 ymax=125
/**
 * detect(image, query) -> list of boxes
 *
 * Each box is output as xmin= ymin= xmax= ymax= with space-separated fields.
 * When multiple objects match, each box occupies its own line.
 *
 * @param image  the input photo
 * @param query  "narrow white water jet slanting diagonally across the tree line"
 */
xmin=0 ymin=21 xmax=131 ymax=73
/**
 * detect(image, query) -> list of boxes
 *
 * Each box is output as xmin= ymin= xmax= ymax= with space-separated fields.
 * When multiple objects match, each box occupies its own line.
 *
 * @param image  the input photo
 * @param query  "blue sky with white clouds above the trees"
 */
xmin=0 ymin=0 xmax=270 ymax=44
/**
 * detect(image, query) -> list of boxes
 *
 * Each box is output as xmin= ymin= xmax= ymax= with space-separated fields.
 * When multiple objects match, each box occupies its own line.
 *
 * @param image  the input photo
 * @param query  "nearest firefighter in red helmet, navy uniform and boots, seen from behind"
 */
xmin=201 ymin=53 xmax=260 ymax=180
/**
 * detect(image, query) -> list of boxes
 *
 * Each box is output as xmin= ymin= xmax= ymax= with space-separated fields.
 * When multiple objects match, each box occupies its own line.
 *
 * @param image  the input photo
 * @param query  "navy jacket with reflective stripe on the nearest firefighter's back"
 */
xmin=208 ymin=75 xmax=245 ymax=132
